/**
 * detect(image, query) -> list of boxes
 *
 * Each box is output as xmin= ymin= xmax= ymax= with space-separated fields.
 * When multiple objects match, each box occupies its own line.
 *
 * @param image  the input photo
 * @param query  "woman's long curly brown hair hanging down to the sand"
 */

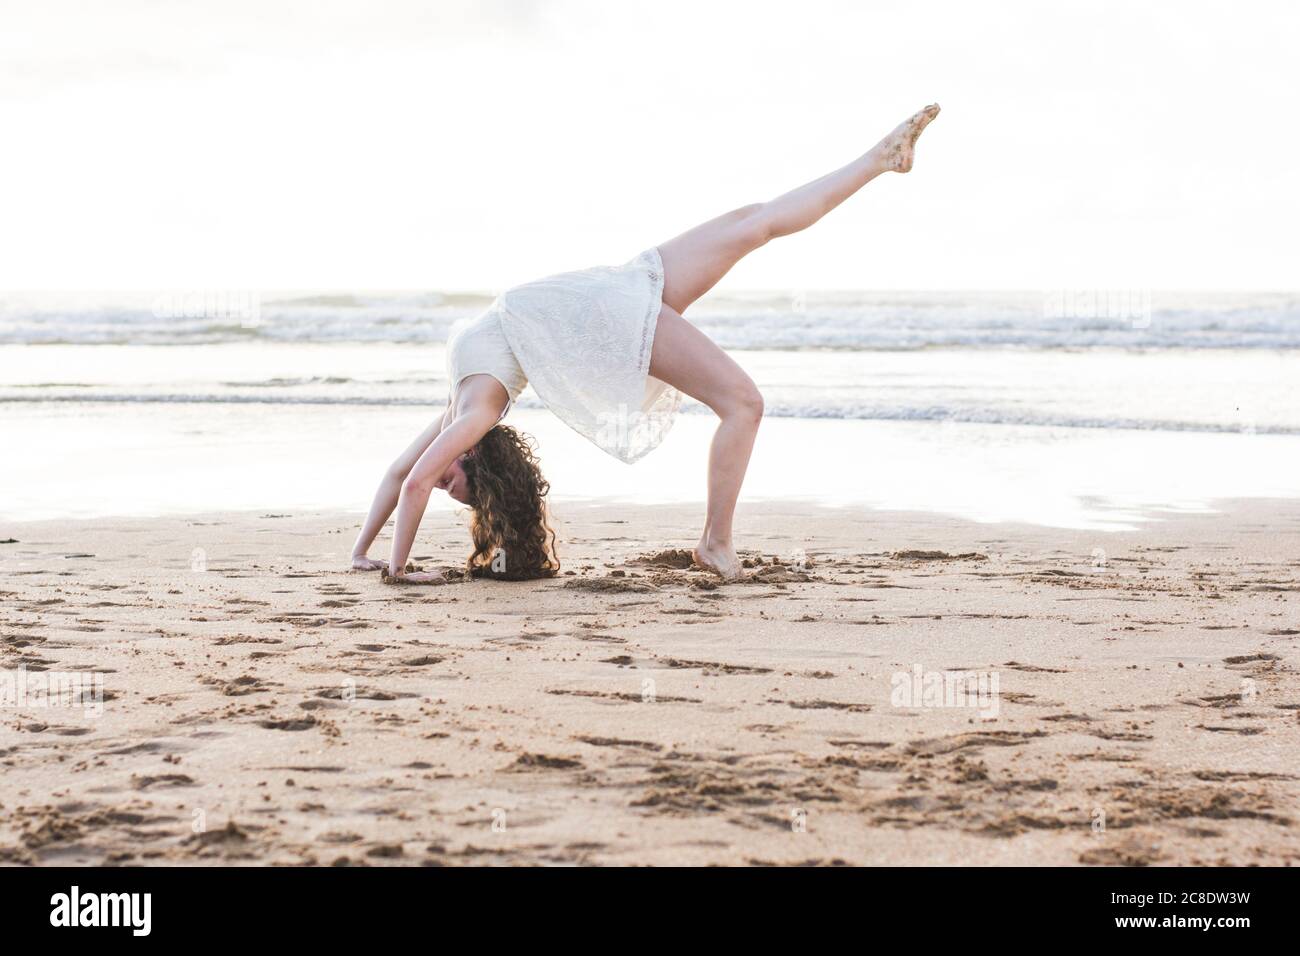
xmin=462 ymin=425 xmax=560 ymax=581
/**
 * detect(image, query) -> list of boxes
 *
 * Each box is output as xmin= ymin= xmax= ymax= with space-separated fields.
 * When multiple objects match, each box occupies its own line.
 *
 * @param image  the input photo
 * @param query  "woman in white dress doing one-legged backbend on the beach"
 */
xmin=352 ymin=105 xmax=939 ymax=584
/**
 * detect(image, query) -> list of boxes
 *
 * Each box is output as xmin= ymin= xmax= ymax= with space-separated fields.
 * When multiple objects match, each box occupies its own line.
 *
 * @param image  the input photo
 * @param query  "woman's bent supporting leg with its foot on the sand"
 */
xmin=650 ymin=304 xmax=763 ymax=579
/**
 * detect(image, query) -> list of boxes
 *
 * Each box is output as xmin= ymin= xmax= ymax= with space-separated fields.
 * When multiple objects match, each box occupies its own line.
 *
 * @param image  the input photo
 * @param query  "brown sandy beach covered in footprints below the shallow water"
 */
xmin=0 ymin=501 xmax=1300 ymax=865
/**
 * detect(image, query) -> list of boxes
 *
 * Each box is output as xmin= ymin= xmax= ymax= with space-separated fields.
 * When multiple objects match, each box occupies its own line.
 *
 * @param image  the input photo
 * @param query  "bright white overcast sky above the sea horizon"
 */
xmin=0 ymin=0 xmax=1300 ymax=290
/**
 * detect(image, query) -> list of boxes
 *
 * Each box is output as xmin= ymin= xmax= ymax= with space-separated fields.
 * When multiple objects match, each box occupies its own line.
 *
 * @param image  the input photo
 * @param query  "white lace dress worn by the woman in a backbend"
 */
xmin=447 ymin=248 xmax=681 ymax=463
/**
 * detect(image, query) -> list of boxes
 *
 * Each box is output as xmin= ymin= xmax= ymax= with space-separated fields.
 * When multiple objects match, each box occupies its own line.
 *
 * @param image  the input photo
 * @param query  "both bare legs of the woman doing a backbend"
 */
xmin=650 ymin=107 xmax=939 ymax=579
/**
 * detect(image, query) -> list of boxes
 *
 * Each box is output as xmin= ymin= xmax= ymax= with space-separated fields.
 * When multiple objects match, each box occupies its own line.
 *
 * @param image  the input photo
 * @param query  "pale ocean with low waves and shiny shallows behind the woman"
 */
xmin=0 ymin=291 xmax=1300 ymax=527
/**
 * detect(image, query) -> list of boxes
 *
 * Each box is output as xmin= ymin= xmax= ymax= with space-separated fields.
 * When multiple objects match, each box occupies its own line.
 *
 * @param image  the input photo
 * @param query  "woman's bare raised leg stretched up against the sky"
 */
xmin=659 ymin=107 xmax=939 ymax=312
